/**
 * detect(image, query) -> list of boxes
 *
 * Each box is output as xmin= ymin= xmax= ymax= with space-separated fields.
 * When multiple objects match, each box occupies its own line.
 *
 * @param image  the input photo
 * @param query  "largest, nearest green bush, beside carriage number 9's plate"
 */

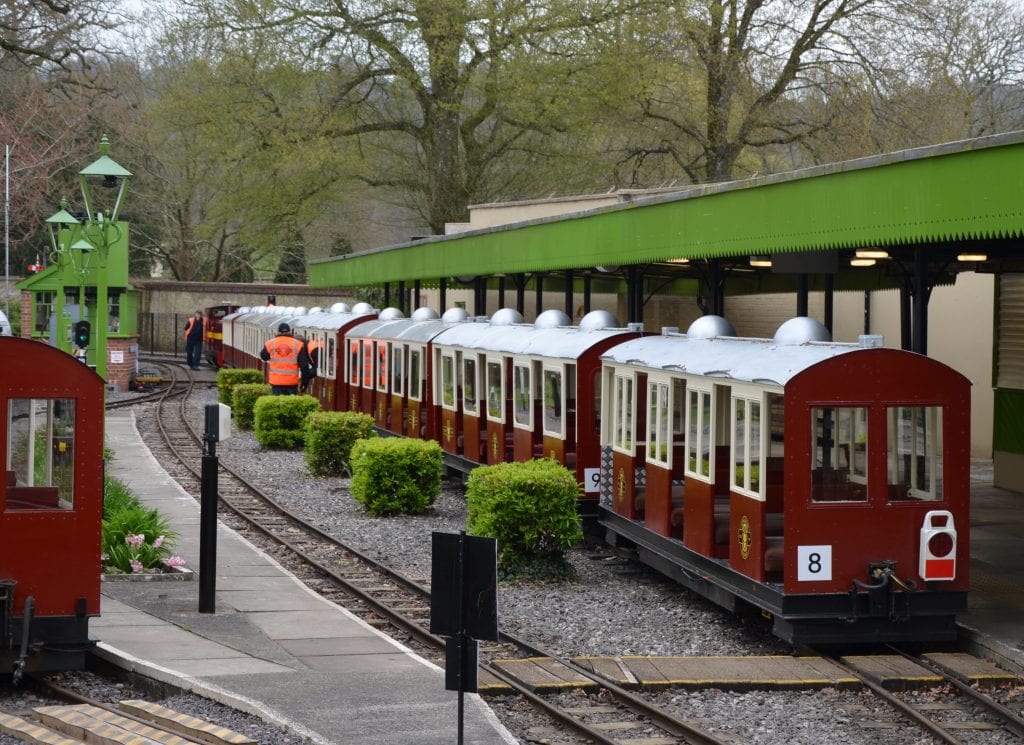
xmin=466 ymin=458 xmax=583 ymax=573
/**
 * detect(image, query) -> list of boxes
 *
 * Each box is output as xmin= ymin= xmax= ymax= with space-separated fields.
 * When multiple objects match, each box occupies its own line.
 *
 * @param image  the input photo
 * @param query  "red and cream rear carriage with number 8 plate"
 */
xmin=601 ymin=316 xmax=970 ymax=643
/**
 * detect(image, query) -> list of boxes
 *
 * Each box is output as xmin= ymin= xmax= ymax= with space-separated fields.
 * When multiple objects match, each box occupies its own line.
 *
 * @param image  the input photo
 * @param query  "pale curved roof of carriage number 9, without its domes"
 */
xmin=434 ymin=323 xmax=628 ymax=359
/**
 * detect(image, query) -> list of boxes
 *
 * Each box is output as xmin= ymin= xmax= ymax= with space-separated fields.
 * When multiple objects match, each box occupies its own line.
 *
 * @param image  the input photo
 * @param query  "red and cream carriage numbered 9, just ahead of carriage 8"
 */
xmin=433 ymin=308 xmax=640 ymax=491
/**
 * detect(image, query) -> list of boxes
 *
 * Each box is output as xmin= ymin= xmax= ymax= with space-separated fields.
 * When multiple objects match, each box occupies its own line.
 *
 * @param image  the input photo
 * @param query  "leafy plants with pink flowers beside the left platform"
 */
xmin=100 ymin=476 xmax=184 ymax=574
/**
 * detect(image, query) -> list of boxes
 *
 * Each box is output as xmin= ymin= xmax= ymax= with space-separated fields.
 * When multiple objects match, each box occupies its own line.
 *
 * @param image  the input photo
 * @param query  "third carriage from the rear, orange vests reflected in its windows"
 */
xmin=345 ymin=308 xmax=468 ymax=440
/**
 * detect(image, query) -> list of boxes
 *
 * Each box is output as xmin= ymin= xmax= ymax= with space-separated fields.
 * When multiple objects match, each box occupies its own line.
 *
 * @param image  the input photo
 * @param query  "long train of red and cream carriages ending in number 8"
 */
xmin=224 ymin=308 xmax=971 ymax=644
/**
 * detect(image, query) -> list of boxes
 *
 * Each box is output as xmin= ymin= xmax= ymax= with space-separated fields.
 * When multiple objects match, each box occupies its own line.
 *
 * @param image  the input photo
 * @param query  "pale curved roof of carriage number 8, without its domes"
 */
xmin=601 ymin=334 xmax=862 ymax=387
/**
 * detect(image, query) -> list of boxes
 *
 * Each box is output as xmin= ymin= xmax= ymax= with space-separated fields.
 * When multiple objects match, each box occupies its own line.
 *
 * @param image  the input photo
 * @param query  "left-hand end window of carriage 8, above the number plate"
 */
xmin=811 ymin=406 xmax=867 ymax=501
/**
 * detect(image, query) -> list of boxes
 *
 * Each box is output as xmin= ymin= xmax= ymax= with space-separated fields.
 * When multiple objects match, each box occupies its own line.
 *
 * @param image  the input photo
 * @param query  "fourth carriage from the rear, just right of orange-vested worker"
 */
xmin=294 ymin=303 xmax=377 ymax=410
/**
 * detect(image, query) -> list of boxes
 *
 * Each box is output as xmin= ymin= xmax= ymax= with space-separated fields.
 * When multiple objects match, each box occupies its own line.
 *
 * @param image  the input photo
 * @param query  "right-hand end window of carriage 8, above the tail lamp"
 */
xmin=886 ymin=406 xmax=942 ymax=500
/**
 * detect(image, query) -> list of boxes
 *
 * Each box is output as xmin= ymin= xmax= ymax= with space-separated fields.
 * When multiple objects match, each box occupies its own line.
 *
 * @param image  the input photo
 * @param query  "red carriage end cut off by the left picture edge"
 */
xmin=0 ymin=337 xmax=103 ymax=677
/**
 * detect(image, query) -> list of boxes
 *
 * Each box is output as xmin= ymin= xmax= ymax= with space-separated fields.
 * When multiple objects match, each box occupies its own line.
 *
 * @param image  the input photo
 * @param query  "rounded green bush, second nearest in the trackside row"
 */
xmin=349 ymin=437 xmax=443 ymax=515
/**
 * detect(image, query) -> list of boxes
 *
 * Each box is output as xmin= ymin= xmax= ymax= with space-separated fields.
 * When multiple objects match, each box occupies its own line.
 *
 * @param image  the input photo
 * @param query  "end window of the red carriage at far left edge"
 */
xmin=5 ymin=398 xmax=75 ymax=510
